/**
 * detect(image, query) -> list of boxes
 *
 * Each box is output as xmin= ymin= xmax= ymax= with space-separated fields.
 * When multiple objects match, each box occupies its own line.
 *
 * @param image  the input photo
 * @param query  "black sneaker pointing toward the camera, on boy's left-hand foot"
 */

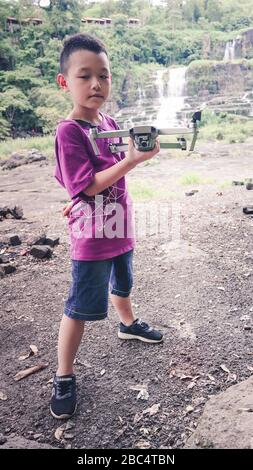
xmin=50 ymin=374 xmax=76 ymax=419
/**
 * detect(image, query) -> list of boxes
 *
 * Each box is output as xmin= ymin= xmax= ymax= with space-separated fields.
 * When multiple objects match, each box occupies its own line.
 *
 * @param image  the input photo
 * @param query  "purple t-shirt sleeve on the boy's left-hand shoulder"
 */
xmin=55 ymin=123 xmax=95 ymax=199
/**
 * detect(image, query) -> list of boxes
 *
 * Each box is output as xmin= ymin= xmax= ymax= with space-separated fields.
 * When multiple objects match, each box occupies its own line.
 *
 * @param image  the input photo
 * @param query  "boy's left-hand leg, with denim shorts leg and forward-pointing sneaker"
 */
xmin=50 ymin=260 xmax=111 ymax=419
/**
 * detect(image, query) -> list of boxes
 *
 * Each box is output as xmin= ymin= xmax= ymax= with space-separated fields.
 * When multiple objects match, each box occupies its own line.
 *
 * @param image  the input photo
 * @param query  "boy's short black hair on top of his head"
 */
xmin=60 ymin=33 xmax=108 ymax=74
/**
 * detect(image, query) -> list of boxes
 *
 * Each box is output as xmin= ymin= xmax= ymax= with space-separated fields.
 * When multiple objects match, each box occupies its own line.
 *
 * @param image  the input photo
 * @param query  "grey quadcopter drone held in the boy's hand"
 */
xmin=89 ymin=110 xmax=202 ymax=156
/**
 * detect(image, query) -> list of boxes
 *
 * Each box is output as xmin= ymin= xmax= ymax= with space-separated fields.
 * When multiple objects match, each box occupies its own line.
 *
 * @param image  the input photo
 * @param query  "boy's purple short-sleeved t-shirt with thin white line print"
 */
xmin=54 ymin=114 xmax=135 ymax=261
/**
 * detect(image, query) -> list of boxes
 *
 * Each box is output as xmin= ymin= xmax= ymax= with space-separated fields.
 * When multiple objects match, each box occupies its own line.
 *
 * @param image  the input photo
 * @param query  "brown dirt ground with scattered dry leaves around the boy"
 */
xmin=0 ymin=140 xmax=253 ymax=449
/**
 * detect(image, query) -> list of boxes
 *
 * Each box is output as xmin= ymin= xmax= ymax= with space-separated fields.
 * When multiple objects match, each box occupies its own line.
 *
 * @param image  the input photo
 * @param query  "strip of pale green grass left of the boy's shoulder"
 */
xmin=0 ymin=135 xmax=54 ymax=159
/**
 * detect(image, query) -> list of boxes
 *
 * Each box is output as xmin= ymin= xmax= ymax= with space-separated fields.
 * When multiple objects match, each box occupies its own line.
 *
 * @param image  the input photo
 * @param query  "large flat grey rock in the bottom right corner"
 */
xmin=185 ymin=376 xmax=253 ymax=449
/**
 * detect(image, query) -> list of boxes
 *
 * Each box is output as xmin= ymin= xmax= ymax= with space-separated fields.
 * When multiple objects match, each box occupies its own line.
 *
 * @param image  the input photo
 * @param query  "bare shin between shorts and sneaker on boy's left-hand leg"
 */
xmin=56 ymin=315 xmax=84 ymax=375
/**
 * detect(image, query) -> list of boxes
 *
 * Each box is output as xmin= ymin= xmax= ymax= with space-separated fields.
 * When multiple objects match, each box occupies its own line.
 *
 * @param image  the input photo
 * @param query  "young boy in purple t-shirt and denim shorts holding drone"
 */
xmin=50 ymin=34 xmax=163 ymax=419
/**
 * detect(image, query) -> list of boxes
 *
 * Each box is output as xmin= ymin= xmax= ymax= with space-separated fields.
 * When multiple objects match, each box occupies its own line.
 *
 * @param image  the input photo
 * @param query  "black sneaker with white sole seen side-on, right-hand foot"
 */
xmin=118 ymin=318 xmax=163 ymax=343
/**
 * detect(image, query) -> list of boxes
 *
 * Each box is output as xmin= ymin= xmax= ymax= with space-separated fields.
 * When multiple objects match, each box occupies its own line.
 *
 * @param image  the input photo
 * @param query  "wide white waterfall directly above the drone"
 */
xmin=155 ymin=67 xmax=186 ymax=128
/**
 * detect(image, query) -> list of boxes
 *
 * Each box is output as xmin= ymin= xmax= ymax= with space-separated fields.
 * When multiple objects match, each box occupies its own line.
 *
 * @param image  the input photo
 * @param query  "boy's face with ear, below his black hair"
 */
xmin=57 ymin=49 xmax=111 ymax=110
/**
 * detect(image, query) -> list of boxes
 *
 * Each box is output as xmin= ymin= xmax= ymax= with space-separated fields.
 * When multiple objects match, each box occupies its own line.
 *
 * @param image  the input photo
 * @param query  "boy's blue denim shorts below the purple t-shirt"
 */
xmin=64 ymin=250 xmax=133 ymax=321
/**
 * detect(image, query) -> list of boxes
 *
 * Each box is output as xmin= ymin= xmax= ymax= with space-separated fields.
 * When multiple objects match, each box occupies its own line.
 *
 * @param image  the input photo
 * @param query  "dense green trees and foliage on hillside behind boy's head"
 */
xmin=0 ymin=0 xmax=253 ymax=139
